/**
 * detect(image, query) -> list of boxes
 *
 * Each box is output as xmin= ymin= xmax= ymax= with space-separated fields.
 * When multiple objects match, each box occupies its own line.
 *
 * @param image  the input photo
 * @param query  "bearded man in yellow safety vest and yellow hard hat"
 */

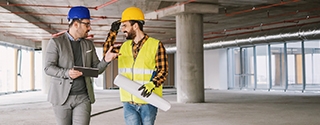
xmin=103 ymin=7 xmax=168 ymax=125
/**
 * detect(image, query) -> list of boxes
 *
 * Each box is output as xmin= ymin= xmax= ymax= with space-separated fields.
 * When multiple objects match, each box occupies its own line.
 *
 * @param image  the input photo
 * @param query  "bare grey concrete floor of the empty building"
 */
xmin=0 ymin=89 xmax=320 ymax=125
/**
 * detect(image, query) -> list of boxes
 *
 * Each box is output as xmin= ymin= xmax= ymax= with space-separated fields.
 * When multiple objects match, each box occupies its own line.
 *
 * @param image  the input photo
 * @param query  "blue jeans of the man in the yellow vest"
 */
xmin=123 ymin=102 xmax=158 ymax=125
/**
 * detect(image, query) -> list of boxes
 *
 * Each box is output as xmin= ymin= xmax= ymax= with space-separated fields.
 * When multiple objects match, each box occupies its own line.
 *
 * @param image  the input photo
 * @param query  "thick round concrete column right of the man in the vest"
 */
xmin=176 ymin=13 xmax=204 ymax=103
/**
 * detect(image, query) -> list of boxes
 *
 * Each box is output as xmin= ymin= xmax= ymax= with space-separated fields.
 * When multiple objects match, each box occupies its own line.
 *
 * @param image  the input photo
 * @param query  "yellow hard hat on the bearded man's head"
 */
xmin=120 ymin=7 xmax=144 ymax=22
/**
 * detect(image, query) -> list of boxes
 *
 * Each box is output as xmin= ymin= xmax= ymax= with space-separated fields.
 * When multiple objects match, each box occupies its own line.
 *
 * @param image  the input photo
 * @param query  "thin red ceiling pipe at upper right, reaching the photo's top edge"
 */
xmin=226 ymin=0 xmax=300 ymax=16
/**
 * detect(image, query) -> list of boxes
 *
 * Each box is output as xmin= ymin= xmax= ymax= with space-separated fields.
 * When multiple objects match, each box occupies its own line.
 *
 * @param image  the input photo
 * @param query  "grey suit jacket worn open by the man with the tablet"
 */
xmin=44 ymin=34 xmax=108 ymax=105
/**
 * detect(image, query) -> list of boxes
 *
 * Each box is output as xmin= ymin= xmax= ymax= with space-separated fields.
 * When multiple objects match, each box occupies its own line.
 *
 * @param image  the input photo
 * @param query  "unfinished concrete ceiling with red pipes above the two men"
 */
xmin=0 ymin=0 xmax=320 ymax=49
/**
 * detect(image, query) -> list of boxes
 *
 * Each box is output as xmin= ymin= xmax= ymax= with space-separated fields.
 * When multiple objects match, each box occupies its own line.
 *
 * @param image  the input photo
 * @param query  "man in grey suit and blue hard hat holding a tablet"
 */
xmin=44 ymin=6 xmax=118 ymax=125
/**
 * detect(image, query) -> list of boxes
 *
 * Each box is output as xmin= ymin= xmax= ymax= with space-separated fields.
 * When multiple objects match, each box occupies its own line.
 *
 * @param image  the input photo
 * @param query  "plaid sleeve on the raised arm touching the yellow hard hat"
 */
xmin=103 ymin=31 xmax=120 ymax=55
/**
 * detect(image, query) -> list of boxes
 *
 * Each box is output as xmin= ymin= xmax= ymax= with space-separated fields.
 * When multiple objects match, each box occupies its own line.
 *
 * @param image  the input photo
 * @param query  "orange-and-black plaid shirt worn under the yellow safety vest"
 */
xmin=103 ymin=31 xmax=169 ymax=87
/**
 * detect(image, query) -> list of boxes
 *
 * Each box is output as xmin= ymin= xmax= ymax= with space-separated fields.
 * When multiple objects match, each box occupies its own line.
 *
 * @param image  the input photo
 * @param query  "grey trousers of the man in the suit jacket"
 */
xmin=53 ymin=94 xmax=91 ymax=125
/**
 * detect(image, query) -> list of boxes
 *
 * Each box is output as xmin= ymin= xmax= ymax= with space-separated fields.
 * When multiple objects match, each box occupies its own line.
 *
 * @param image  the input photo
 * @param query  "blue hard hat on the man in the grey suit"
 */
xmin=68 ymin=6 xmax=91 ymax=20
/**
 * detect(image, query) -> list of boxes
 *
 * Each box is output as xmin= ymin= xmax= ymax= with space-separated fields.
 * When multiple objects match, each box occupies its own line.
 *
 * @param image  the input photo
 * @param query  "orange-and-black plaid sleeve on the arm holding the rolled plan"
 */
xmin=152 ymin=42 xmax=169 ymax=87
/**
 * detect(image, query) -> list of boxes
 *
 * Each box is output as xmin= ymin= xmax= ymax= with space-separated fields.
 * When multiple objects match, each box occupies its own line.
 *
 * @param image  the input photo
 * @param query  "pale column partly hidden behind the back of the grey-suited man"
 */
xmin=41 ymin=40 xmax=51 ymax=94
